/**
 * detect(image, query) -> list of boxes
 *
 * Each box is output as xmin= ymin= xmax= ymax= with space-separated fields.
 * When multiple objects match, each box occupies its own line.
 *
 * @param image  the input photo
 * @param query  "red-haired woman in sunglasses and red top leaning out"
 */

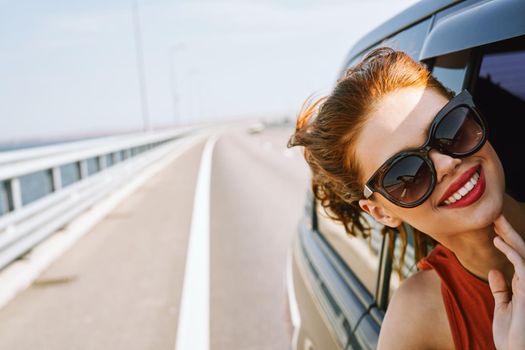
xmin=289 ymin=48 xmax=525 ymax=349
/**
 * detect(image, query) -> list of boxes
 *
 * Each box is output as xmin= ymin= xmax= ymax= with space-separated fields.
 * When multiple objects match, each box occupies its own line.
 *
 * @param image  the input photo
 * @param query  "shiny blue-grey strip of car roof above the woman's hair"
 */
xmin=346 ymin=0 xmax=463 ymax=62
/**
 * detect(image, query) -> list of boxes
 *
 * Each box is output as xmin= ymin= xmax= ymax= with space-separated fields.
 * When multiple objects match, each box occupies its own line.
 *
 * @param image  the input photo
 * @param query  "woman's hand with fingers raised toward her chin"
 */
xmin=489 ymin=215 xmax=525 ymax=350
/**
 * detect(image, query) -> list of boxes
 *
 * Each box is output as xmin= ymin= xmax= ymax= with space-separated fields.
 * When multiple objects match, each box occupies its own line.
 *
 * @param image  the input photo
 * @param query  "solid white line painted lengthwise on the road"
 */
xmin=175 ymin=135 xmax=218 ymax=350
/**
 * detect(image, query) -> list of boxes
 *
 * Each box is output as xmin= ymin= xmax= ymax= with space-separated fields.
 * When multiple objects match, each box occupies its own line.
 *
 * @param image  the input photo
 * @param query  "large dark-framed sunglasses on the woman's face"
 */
xmin=364 ymin=90 xmax=487 ymax=208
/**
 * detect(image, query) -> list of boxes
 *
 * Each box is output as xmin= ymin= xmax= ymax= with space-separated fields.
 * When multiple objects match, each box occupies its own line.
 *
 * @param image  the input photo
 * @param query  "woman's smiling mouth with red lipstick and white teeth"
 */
xmin=439 ymin=166 xmax=485 ymax=208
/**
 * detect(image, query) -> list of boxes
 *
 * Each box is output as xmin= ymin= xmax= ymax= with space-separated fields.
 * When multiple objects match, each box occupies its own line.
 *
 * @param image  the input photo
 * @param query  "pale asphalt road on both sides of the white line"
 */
xmin=0 ymin=127 xmax=308 ymax=350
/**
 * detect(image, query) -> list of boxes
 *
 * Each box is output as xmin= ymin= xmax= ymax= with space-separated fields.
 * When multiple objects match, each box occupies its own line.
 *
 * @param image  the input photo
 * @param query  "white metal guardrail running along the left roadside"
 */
xmin=0 ymin=128 xmax=196 ymax=269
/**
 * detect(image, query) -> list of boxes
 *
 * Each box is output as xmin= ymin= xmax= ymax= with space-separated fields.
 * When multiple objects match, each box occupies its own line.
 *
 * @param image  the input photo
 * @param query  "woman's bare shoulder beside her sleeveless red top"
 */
xmin=378 ymin=270 xmax=453 ymax=349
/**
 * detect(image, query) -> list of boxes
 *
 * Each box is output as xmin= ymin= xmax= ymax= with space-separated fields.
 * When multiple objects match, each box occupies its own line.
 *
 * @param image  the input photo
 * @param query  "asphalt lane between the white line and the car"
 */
xmin=211 ymin=129 xmax=307 ymax=350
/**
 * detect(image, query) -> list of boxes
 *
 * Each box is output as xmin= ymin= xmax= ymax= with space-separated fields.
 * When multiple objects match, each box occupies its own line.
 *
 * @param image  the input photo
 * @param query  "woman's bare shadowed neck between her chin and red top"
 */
xmin=443 ymin=194 xmax=525 ymax=284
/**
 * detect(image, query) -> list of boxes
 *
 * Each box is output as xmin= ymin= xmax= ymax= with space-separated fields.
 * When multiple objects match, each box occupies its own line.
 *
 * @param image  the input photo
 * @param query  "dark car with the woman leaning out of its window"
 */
xmin=287 ymin=0 xmax=525 ymax=350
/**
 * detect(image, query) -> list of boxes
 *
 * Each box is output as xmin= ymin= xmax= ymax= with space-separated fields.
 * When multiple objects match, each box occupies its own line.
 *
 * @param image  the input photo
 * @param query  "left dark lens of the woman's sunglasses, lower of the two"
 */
xmin=383 ymin=156 xmax=432 ymax=204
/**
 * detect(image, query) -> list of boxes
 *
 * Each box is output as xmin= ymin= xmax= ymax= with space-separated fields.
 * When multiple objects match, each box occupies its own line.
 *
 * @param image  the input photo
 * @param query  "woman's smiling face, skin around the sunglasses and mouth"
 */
xmin=355 ymin=88 xmax=505 ymax=241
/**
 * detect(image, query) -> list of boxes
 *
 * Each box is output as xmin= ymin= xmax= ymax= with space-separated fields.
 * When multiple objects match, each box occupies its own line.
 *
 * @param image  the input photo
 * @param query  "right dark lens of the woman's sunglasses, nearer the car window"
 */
xmin=435 ymin=106 xmax=484 ymax=154
